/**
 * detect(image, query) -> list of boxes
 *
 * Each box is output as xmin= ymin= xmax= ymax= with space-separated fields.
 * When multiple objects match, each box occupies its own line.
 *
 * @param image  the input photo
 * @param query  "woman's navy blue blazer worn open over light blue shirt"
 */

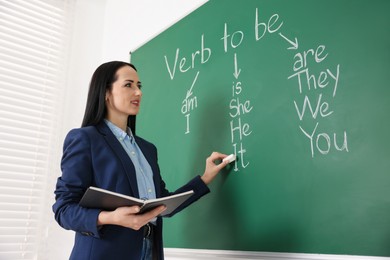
xmin=53 ymin=122 xmax=210 ymax=260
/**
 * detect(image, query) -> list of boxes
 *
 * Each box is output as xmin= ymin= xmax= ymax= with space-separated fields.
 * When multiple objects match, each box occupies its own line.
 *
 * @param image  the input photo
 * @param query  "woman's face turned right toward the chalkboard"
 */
xmin=106 ymin=66 xmax=142 ymax=123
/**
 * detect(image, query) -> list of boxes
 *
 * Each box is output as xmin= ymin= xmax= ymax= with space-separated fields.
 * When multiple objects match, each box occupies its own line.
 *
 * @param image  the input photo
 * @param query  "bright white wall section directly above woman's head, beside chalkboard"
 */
xmin=103 ymin=0 xmax=207 ymax=61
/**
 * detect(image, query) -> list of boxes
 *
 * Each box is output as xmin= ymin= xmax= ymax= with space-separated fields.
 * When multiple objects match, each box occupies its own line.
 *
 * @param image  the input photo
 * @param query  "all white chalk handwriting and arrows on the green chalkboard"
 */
xmin=164 ymin=8 xmax=348 ymax=160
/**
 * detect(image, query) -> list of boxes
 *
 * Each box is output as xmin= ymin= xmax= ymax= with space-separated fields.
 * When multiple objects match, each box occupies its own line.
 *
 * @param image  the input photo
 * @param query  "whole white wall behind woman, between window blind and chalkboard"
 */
xmin=47 ymin=0 xmax=207 ymax=260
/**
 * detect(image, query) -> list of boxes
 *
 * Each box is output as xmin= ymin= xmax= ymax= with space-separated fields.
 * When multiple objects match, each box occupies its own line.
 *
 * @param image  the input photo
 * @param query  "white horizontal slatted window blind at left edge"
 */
xmin=0 ymin=0 xmax=74 ymax=259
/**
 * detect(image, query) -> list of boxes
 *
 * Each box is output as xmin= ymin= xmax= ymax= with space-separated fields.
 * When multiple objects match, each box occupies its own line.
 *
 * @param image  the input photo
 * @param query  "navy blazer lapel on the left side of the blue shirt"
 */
xmin=96 ymin=122 xmax=139 ymax=198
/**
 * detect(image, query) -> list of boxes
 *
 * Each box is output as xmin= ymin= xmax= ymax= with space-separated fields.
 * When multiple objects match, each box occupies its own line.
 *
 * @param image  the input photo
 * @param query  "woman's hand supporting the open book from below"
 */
xmin=97 ymin=205 xmax=166 ymax=230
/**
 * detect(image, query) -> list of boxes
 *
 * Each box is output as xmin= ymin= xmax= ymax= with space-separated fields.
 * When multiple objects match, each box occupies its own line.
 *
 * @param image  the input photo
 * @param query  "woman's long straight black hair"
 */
xmin=81 ymin=61 xmax=137 ymax=135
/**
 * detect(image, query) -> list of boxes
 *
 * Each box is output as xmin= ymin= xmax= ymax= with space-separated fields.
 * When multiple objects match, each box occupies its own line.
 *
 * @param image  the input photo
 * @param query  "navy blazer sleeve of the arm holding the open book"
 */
xmin=52 ymin=129 xmax=100 ymax=237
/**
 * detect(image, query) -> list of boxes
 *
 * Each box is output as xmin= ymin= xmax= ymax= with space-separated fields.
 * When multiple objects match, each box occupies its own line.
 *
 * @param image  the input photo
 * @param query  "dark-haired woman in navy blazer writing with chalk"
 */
xmin=53 ymin=61 xmax=228 ymax=260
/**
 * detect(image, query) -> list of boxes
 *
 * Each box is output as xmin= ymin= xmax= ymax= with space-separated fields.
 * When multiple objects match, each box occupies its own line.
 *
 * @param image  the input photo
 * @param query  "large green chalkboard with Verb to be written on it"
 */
xmin=131 ymin=0 xmax=390 ymax=256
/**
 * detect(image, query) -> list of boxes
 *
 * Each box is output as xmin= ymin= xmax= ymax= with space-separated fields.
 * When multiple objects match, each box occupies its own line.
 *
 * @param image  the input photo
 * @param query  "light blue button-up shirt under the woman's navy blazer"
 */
xmin=104 ymin=119 xmax=156 ymax=200
